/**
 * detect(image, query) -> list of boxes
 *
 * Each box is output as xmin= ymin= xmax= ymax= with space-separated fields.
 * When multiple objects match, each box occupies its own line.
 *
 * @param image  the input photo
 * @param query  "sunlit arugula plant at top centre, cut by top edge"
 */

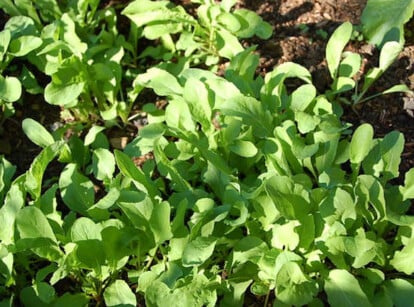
xmin=122 ymin=0 xmax=272 ymax=69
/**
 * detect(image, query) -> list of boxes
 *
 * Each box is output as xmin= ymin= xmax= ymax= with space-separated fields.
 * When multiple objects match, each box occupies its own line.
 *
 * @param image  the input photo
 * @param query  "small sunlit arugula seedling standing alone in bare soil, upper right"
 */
xmin=326 ymin=22 xmax=411 ymax=106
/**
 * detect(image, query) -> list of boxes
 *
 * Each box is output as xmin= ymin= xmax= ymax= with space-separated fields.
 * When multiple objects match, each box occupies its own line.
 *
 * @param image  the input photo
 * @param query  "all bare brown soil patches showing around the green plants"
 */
xmin=0 ymin=0 xmax=414 ymax=181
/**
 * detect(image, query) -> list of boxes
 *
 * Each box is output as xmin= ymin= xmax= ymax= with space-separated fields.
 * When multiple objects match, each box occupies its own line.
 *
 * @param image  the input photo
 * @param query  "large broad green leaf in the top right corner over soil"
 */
xmin=361 ymin=0 xmax=414 ymax=46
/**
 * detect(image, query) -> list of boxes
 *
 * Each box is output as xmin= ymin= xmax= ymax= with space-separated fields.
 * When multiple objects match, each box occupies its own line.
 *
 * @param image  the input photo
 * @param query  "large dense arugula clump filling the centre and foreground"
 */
xmin=4 ymin=45 xmax=414 ymax=306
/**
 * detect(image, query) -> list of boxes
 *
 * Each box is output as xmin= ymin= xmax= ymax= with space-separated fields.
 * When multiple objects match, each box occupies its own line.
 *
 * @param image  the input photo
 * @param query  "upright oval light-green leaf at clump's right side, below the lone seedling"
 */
xmin=349 ymin=124 xmax=374 ymax=164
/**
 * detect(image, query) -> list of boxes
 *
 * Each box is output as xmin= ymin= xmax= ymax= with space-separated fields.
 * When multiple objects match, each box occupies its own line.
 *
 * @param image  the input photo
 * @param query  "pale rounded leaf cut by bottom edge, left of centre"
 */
xmin=104 ymin=279 xmax=137 ymax=307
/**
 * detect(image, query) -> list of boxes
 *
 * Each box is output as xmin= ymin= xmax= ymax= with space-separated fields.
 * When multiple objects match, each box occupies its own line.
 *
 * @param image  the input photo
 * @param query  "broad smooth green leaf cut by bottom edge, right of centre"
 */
xmin=325 ymin=269 xmax=371 ymax=307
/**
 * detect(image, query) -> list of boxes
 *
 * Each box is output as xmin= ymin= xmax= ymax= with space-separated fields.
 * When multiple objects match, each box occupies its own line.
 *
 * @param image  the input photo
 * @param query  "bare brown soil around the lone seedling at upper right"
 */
xmin=236 ymin=0 xmax=414 ymax=181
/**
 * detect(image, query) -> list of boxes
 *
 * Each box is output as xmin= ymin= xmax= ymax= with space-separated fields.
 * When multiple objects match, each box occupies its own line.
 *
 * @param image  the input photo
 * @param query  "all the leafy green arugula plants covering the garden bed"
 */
xmin=0 ymin=0 xmax=414 ymax=306
